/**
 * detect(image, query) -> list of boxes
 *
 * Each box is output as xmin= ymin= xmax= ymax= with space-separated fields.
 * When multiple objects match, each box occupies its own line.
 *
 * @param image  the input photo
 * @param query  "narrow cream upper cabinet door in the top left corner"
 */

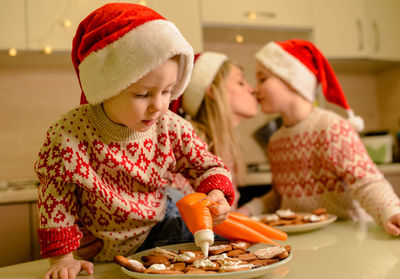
xmin=0 ymin=0 xmax=27 ymax=49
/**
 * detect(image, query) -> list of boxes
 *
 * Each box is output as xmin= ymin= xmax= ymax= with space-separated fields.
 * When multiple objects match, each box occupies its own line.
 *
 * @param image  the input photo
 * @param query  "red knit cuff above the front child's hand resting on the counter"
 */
xmin=37 ymin=225 xmax=82 ymax=258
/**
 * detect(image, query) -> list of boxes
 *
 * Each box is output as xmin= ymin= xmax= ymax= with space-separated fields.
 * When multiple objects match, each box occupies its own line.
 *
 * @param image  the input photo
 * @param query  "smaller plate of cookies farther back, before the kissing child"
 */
xmin=252 ymin=208 xmax=337 ymax=233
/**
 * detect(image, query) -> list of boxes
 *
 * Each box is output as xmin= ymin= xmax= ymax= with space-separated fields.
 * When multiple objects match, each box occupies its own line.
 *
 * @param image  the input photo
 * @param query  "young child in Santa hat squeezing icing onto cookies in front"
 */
xmin=35 ymin=3 xmax=234 ymax=278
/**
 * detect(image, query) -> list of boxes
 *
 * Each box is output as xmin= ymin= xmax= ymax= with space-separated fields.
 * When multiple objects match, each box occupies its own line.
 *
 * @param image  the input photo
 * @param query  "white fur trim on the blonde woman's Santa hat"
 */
xmin=182 ymin=51 xmax=228 ymax=117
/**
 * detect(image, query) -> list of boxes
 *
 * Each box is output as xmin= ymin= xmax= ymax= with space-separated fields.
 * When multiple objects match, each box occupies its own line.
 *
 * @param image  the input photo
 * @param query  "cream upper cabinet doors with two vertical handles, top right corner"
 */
xmin=313 ymin=0 xmax=400 ymax=61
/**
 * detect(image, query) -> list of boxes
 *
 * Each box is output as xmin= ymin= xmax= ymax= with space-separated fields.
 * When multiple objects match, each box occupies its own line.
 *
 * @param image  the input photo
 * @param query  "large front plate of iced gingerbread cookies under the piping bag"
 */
xmin=114 ymin=241 xmax=292 ymax=279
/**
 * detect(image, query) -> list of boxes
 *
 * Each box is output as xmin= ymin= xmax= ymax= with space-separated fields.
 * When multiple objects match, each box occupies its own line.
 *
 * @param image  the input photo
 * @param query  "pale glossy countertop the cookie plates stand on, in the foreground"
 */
xmin=0 ymin=221 xmax=400 ymax=279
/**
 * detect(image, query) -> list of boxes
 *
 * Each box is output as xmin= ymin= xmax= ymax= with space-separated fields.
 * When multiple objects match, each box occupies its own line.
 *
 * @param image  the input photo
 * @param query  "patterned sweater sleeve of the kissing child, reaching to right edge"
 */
xmin=324 ymin=119 xmax=400 ymax=225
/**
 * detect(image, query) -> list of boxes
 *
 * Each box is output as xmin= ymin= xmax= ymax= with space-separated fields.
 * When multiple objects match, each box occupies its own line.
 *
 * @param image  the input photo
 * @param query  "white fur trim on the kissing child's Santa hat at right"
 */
xmin=255 ymin=42 xmax=318 ymax=102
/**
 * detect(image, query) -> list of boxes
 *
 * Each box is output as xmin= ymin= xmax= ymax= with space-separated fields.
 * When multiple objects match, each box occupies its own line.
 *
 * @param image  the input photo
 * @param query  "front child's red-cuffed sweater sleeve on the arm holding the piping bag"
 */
xmin=170 ymin=114 xmax=235 ymax=205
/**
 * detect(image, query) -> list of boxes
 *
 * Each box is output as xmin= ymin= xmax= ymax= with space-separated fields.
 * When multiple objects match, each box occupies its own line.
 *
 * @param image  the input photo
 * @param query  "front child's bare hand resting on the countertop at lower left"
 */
xmin=44 ymin=253 xmax=93 ymax=279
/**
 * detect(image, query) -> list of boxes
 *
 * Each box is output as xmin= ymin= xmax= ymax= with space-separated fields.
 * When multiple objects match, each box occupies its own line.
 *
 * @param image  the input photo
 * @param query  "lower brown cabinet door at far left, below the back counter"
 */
xmin=0 ymin=203 xmax=31 ymax=266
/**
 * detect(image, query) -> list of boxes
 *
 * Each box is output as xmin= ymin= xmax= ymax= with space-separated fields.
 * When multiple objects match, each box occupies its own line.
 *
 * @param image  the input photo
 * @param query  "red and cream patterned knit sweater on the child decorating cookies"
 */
xmin=35 ymin=105 xmax=234 ymax=261
